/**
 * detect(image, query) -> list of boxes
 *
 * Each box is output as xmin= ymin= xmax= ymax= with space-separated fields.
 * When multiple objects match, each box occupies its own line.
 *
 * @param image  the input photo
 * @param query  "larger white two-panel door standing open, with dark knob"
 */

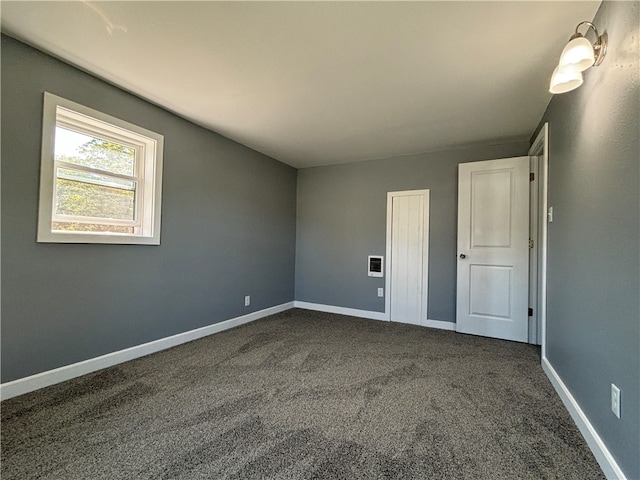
xmin=456 ymin=157 xmax=529 ymax=342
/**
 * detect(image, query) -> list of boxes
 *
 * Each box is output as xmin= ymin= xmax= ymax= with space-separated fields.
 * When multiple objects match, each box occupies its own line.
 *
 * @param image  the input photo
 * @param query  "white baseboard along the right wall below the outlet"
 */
xmin=542 ymin=357 xmax=627 ymax=480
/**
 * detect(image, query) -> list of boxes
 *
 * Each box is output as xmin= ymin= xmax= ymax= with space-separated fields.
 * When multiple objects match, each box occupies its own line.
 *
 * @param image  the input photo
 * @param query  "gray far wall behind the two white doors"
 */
xmin=296 ymin=142 xmax=529 ymax=322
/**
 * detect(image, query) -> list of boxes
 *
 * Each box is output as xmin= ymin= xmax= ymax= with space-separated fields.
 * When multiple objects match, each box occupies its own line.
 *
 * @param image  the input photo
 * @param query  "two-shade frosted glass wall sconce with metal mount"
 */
xmin=549 ymin=22 xmax=607 ymax=94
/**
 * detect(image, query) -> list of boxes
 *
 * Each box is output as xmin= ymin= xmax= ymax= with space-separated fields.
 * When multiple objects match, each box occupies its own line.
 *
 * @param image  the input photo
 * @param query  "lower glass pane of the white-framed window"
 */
xmin=55 ymin=168 xmax=136 ymax=220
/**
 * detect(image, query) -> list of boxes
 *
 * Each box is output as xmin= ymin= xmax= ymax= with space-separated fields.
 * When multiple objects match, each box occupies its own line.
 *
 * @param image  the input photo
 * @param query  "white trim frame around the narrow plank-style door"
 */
xmin=384 ymin=189 xmax=430 ymax=325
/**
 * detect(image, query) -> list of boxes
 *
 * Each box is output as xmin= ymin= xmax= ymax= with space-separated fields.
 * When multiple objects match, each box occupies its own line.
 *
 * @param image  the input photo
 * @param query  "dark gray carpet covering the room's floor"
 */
xmin=1 ymin=310 xmax=604 ymax=480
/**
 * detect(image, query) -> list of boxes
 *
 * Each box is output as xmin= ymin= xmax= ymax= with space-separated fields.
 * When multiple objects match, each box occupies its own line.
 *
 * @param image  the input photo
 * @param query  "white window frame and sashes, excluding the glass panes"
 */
xmin=38 ymin=92 xmax=164 ymax=245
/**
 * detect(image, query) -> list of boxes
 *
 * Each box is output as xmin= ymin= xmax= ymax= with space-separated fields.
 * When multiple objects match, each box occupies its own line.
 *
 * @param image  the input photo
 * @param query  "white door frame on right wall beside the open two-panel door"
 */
xmin=529 ymin=122 xmax=549 ymax=358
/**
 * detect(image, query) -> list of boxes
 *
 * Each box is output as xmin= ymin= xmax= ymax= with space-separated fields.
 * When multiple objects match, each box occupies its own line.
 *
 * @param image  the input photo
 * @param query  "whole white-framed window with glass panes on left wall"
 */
xmin=38 ymin=92 xmax=163 ymax=245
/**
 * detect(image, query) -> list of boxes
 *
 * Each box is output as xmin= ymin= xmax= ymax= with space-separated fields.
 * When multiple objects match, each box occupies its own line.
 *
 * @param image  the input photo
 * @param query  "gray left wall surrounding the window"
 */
xmin=1 ymin=36 xmax=296 ymax=382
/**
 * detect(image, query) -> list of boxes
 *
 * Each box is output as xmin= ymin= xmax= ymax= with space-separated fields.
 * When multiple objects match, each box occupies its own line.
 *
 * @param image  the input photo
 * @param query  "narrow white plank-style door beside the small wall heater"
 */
xmin=387 ymin=190 xmax=429 ymax=325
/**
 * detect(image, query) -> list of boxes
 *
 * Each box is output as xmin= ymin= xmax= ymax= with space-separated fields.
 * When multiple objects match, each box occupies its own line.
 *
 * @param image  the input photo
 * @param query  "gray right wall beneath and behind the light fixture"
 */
xmin=543 ymin=2 xmax=640 ymax=479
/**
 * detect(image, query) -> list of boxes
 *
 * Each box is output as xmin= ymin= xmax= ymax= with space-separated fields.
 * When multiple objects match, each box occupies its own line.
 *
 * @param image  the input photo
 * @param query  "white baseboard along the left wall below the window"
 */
xmin=0 ymin=302 xmax=294 ymax=400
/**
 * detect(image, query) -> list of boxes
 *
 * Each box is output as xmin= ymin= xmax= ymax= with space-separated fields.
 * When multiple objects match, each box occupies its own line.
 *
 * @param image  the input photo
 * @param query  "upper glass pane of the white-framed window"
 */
xmin=55 ymin=127 xmax=136 ymax=176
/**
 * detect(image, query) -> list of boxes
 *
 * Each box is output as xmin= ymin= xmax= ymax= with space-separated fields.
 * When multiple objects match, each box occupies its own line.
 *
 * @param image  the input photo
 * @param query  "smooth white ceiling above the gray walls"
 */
xmin=1 ymin=1 xmax=600 ymax=167
